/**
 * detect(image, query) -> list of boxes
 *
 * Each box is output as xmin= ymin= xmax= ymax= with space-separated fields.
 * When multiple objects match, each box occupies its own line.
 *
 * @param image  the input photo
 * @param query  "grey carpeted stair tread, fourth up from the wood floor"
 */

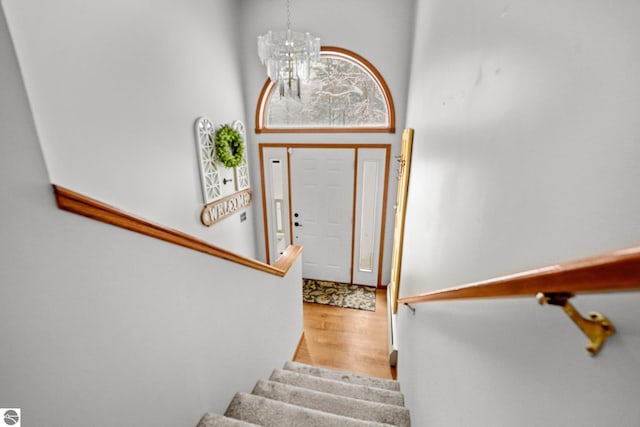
xmin=225 ymin=392 xmax=396 ymax=427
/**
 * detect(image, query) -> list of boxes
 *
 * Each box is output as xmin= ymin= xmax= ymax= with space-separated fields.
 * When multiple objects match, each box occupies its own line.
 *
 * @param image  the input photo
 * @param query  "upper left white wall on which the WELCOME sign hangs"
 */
xmin=3 ymin=0 xmax=256 ymax=257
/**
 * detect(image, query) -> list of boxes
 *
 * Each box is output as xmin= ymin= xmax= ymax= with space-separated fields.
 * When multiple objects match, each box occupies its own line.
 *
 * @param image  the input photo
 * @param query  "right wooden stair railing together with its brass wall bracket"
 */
xmin=398 ymin=246 xmax=640 ymax=356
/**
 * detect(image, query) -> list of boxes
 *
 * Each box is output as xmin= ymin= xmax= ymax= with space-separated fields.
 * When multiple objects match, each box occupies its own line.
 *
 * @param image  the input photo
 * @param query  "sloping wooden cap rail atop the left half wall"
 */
xmin=53 ymin=185 xmax=302 ymax=277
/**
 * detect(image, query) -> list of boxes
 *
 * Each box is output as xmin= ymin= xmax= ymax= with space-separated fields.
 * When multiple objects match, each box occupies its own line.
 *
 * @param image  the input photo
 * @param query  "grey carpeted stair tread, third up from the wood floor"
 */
xmin=253 ymin=380 xmax=411 ymax=427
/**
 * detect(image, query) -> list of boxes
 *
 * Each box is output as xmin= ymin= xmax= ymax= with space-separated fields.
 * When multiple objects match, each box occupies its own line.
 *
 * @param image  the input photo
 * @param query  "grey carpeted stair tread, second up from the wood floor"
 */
xmin=269 ymin=369 xmax=404 ymax=406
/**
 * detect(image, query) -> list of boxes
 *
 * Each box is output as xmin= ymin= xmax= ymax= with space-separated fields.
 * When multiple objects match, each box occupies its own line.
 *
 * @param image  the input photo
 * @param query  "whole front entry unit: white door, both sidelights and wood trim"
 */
xmin=260 ymin=144 xmax=390 ymax=286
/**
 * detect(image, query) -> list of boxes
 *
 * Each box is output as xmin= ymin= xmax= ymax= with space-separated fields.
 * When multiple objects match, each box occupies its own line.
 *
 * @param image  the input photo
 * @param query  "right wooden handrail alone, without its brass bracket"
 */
xmin=398 ymin=246 xmax=640 ymax=304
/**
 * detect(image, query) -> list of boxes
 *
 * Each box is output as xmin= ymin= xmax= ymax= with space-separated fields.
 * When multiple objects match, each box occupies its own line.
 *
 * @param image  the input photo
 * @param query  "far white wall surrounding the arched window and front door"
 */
xmin=240 ymin=0 xmax=414 ymax=283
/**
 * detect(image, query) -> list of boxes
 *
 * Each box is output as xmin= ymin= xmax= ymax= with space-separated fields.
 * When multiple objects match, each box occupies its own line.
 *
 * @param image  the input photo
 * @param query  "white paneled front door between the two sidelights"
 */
xmin=290 ymin=148 xmax=355 ymax=283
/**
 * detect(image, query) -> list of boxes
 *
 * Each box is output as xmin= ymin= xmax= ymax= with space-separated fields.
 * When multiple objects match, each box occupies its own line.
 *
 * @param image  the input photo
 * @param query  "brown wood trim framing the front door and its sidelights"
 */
xmin=258 ymin=142 xmax=391 ymax=288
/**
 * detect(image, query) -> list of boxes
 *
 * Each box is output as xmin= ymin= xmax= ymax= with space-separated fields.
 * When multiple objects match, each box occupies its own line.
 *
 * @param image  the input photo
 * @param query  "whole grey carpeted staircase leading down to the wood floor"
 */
xmin=197 ymin=362 xmax=411 ymax=427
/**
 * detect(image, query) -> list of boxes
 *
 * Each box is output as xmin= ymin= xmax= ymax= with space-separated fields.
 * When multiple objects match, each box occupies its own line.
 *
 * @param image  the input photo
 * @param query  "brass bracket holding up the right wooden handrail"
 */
xmin=536 ymin=292 xmax=616 ymax=356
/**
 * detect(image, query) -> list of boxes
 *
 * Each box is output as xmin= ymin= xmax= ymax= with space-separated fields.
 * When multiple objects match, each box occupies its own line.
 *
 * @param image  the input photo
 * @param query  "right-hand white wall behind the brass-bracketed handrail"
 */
xmin=399 ymin=0 xmax=640 ymax=427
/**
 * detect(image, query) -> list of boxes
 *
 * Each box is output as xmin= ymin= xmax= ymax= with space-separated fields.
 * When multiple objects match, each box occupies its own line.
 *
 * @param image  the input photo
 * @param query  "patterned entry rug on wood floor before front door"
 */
xmin=302 ymin=279 xmax=376 ymax=311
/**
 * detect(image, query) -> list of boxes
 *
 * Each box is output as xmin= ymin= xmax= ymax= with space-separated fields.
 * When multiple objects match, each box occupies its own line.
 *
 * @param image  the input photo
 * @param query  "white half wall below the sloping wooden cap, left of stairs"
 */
xmin=0 ymin=2 xmax=302 ymax=427
